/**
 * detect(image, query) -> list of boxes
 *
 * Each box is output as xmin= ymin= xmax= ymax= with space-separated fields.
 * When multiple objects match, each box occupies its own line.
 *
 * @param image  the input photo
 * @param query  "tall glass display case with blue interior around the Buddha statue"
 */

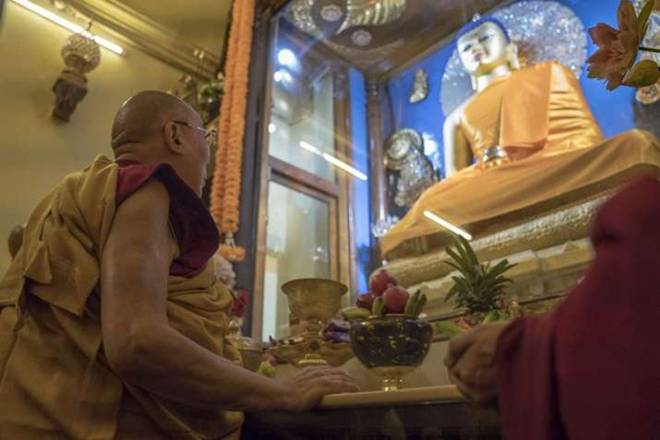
xmin=248 ymin=0 xmax=658 ymax=340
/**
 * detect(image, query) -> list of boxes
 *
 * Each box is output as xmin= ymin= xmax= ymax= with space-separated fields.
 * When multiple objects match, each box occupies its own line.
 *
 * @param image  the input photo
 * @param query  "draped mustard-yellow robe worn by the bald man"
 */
xmin=0 ymin=156 xmax=242 ymax=440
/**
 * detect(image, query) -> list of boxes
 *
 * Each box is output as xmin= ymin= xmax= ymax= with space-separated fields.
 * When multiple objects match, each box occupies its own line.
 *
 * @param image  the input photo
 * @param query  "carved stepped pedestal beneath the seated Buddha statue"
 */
xmin=385 ymin=196 xmax=607 ymax=320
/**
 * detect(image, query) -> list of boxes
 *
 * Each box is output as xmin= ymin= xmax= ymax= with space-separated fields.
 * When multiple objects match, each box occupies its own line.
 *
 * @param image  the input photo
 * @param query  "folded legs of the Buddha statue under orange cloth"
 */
xmin=381 ymin=130 xmax=660 ymax=254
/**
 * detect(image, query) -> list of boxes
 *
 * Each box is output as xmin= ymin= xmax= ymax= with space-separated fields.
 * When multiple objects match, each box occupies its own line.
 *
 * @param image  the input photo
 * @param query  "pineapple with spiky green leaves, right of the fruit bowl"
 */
xmin=445 ymin=236 xmax=514 ymax=325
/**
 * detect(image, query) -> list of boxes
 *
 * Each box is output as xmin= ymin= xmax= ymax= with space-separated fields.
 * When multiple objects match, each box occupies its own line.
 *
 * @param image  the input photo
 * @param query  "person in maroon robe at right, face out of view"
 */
xmin=445 ymin=179 xmax=660 ymax=440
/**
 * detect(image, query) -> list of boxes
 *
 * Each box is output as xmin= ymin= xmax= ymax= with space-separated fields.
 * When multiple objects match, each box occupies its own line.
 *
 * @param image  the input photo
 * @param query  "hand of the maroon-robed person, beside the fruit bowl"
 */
xmin=445 ymin=322 xmax=507 ymax=404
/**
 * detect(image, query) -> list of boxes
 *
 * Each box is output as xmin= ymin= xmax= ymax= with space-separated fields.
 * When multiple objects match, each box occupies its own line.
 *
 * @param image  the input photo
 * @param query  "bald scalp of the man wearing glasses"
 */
xmin=111 ymin=90 xmax=197 ymax=150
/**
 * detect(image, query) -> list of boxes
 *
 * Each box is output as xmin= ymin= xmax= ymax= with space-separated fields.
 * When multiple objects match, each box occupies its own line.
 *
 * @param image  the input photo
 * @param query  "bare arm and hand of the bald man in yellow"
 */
xmin=101 ymin=181 xmax=354 ymax=410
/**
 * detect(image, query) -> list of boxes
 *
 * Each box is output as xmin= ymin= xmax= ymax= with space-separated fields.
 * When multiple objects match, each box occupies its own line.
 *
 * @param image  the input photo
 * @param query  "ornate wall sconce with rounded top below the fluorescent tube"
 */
xmin=52 ymin=34 xmax=101 ymax=122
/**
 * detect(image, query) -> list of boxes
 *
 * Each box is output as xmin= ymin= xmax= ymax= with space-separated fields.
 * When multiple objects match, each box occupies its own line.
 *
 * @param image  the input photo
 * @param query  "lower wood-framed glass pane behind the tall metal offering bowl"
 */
xmin=262 ymin=182 xmax=330 ymax=340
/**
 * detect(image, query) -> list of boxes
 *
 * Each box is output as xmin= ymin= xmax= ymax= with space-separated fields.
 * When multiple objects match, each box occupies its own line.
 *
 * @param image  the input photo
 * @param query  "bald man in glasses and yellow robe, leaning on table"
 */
xmin=0 ymin=91 xmax=356 ymax=439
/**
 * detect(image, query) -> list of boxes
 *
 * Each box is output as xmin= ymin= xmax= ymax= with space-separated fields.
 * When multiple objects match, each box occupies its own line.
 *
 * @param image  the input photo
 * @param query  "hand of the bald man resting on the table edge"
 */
xmin=283 ymin=367 xmax=360 ymax=411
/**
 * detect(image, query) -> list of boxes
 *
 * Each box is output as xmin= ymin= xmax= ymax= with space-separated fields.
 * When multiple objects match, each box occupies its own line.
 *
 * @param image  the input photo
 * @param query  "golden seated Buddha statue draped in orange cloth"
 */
xmin=380 ymin=18 xmax=660 ymax=257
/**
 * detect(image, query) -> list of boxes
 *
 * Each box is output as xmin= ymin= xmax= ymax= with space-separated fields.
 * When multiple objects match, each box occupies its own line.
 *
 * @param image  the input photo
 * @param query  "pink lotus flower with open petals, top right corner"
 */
xmin=587 ymin=0 xmax=640 ymax=90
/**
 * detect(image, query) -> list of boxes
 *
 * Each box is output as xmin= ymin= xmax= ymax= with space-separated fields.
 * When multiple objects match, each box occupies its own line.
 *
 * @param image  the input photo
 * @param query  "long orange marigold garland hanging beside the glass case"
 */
xmin=211 ymin=0 xmax=255 ymax=262
